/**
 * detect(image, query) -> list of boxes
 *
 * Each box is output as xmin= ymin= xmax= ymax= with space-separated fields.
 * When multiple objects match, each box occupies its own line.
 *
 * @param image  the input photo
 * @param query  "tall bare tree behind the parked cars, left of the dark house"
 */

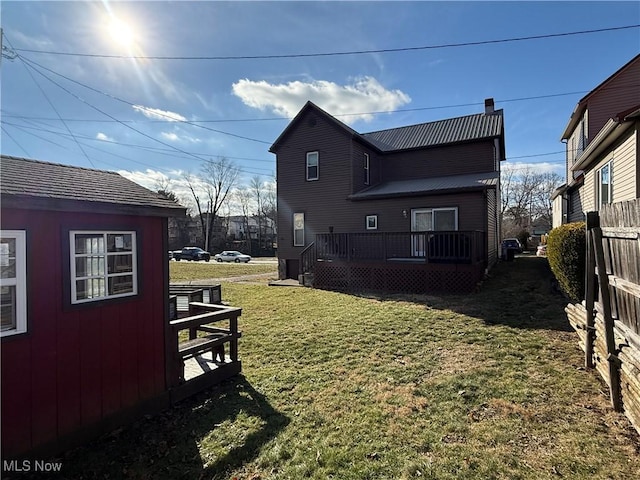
xmin=184 ymin=157 xmax=240 ymax=250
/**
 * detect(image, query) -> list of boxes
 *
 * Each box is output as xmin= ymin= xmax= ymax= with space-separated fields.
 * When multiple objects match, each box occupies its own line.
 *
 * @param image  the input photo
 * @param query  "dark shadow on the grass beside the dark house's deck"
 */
xmin=380 ymin=254 xmax=573 ymax=332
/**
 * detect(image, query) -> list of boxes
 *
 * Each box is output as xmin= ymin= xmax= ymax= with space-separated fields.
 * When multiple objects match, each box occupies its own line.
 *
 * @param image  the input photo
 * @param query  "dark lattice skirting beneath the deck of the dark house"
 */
xmin=313 ymin=261 xmax=484 ymax=293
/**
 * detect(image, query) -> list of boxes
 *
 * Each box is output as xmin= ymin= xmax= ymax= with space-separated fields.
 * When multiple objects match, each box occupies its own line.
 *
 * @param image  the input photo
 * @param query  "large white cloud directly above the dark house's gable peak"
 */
xmin=233 ymin=77 xmax=411 ymax=121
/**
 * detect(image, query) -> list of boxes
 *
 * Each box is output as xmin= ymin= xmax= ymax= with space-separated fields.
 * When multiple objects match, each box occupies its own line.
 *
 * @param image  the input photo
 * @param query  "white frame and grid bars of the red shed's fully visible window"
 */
xmin=69 ymin=230 xmax=138 ymax=305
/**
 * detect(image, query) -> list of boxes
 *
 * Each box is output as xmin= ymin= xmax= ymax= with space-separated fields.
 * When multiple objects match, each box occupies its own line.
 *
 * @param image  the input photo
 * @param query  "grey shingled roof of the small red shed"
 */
xmin=0 ymin=155 xmax=184 ymax=210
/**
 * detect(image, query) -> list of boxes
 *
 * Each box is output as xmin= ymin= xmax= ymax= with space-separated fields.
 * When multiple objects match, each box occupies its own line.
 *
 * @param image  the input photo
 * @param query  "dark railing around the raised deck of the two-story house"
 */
xmin=314 ymin=230 xmax=486 ymax=263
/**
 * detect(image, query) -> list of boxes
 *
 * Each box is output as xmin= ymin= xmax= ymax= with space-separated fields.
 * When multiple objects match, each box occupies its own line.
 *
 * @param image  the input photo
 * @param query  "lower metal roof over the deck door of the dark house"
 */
xmin=349 ymin=172 xmax=499 ymax=200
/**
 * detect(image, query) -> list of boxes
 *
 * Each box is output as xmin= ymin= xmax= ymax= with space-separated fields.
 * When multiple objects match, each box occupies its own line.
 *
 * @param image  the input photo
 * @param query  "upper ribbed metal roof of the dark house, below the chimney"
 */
xmin=360 ymin=110 xmax=503 ymax=152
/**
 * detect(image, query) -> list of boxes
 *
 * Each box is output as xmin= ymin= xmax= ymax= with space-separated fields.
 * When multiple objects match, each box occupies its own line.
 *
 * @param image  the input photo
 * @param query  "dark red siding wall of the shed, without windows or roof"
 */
xmin=1 ymin=210 xmax=166 ymax=455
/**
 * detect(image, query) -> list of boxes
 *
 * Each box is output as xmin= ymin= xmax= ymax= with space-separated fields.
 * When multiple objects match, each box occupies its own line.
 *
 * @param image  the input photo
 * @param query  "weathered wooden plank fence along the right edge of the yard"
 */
xmin=565 ymin=199 xmax=640 ymax=432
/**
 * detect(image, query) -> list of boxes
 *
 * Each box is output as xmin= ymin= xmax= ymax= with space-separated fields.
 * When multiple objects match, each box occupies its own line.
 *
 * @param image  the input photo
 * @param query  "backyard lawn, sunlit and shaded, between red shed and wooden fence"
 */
xmin=27 ymin=257 xmax=640 ymax=480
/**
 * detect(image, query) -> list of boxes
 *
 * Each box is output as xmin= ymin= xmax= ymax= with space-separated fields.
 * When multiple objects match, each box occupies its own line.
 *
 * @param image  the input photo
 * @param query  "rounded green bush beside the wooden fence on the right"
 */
xmin=547 ymin=222 xmax=586 ymax=302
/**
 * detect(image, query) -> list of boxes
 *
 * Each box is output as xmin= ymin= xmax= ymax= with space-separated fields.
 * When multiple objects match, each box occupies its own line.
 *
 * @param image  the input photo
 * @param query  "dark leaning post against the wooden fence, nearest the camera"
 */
xmin=591 ymin=227 xmax=622 ymax=412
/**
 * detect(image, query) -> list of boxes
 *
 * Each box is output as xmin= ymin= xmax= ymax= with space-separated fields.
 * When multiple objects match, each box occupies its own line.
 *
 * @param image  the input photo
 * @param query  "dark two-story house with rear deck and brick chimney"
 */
xmin=270 ymin=99 xmax=505 ymax=291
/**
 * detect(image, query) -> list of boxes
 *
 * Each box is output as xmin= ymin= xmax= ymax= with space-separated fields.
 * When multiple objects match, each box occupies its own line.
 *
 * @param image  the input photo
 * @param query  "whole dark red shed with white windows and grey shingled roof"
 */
xmin=0 ymin=155 xmax=240 ymax=458
